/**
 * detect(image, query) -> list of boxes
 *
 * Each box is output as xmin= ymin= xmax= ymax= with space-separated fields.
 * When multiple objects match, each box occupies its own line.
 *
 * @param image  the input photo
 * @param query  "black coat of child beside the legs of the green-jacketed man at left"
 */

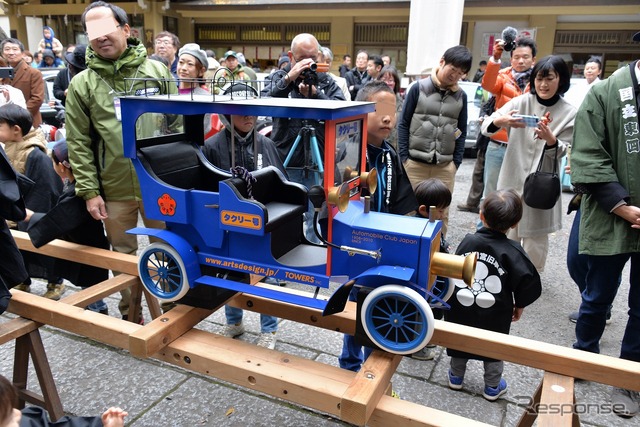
xmin=27 ymin=183 xmax=109 ymax=288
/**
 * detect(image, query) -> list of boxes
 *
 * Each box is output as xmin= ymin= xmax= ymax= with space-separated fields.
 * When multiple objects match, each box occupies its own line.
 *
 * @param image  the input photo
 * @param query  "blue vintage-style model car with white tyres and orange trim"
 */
xmin=121 ymin=85 xmax=475 ymax=354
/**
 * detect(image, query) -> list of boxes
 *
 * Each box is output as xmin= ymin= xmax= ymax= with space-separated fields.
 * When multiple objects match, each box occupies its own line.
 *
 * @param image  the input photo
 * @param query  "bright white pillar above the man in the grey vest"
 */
xmin=406 ymin=0 xmax=464 ymax=75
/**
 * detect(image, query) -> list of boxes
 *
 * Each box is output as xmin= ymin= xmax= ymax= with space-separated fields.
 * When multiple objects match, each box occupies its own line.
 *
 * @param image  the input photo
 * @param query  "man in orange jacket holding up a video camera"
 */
xmin=482 ymin=27 xmax=536 ymax=203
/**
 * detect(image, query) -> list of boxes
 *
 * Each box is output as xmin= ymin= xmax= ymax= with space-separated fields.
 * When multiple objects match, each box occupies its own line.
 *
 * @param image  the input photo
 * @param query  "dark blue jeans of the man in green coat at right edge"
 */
xmin=573 ymin=252 xmax=640 ymax=362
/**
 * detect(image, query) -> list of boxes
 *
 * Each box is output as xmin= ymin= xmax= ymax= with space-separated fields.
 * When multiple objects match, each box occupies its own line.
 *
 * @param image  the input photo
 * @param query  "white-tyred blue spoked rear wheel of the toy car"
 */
xmin=138 ymin=243 xmax=189 ymax=302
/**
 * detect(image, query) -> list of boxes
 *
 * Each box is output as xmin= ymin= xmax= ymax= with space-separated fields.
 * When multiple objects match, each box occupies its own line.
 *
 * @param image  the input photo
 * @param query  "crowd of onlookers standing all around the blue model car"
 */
xmin=0 ymin=1 xmax=640 ymax=422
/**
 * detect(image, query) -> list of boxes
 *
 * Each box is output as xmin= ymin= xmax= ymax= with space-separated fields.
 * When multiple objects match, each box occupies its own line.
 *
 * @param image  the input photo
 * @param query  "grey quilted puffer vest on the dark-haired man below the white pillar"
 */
xmin=409 ymin=78 xmax=466 ymax=164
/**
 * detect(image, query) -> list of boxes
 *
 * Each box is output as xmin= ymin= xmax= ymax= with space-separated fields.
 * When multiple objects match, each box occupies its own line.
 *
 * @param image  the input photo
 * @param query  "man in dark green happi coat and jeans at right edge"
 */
xmin=571 ymin=32 xmax=640 ymax=417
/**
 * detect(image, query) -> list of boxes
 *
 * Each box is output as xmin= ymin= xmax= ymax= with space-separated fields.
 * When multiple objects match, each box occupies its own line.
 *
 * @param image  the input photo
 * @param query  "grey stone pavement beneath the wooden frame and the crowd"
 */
xmin=0 ymin=159 xmax=640 ymax=427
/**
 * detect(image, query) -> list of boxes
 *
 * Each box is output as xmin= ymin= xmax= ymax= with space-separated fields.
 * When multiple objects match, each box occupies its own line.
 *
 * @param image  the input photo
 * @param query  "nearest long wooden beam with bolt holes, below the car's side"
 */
xmin=155 ymin=329 xmax=487 ymax=427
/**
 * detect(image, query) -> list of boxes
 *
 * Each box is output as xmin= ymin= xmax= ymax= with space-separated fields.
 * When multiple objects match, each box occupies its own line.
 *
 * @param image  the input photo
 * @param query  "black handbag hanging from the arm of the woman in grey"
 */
xmin=522 ymin=143 xmax=560 ymax=209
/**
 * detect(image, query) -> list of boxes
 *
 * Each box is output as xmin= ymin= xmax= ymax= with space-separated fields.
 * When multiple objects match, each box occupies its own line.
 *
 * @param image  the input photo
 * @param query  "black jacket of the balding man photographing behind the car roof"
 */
xmin=261 ymin=67 xmax=345 ymax=167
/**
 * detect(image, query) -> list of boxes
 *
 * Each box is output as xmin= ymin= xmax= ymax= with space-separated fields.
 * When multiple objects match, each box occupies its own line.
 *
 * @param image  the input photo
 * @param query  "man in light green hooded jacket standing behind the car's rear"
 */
xmin=66 ymin=1 xmax=177 ymax=320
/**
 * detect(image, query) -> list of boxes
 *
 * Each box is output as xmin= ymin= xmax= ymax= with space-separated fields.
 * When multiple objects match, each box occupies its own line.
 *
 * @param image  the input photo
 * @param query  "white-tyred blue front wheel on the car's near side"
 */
xmin=360 ymin=285 xmax=434 ymax=354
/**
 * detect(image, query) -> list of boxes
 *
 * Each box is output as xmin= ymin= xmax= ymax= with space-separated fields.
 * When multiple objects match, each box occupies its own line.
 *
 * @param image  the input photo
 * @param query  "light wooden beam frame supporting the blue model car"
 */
xmin=6 ymin=232 xmax=640 ymax=426
